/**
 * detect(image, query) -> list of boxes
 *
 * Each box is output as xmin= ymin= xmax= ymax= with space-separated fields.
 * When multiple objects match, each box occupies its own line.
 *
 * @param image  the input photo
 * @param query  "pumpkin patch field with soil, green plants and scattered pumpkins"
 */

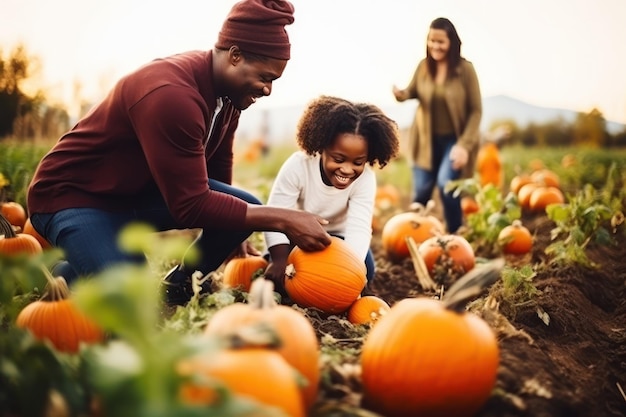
xmin=0 ymin=141 xmax=626 ymax=417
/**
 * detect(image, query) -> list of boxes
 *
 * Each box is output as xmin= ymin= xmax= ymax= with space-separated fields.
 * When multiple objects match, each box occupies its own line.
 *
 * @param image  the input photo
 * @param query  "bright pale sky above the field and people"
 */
xmin=0 ymin=0 xmax=626 ymax=123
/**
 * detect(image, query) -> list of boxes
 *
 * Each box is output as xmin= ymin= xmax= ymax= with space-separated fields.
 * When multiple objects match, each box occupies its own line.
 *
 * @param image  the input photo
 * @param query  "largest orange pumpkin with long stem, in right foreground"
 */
xmin=360 ymin=262 xmax=503 ymax=417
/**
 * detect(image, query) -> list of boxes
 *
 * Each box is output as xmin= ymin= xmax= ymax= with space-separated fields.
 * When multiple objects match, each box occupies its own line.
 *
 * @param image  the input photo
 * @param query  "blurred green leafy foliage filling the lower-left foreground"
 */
xmin=0 ymin=225 xmax=282 ymax=417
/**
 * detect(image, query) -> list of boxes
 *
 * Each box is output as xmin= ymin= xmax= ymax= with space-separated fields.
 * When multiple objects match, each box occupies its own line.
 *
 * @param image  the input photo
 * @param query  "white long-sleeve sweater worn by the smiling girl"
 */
xmin=264 ymin=151 xmax=376 ymax=259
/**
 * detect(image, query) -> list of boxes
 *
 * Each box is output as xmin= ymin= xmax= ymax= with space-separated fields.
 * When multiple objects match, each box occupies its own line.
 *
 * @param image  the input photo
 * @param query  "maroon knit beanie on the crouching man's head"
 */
xmin=215 ymin=0 xmax=294 ymax=59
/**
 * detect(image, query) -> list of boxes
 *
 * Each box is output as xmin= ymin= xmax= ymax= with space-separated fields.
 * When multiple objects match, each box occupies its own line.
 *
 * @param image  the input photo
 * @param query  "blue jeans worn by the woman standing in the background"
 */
xmin=413 ymin=134 xmax=463 ymax=233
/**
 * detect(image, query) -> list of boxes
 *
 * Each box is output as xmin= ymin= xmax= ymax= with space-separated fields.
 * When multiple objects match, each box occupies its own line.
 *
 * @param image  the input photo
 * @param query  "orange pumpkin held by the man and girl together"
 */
xmin=285 ymin=237 xmax=367 ymax=314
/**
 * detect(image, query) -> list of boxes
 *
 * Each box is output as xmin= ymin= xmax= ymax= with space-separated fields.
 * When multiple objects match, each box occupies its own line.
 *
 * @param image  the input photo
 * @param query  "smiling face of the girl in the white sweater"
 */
xmin=321 ymin=133 xmax=367 ymax=189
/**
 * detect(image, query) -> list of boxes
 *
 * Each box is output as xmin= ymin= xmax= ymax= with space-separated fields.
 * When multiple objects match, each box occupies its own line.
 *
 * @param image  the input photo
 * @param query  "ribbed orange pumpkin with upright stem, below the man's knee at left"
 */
xmin=15 ymin=268 xmax=104 ymax=353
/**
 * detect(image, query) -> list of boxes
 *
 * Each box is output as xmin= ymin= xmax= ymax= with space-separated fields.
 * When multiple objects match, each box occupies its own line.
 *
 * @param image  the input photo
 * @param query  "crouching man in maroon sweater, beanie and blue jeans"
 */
xmin=28 ymin=0 xmax=330 ymax=304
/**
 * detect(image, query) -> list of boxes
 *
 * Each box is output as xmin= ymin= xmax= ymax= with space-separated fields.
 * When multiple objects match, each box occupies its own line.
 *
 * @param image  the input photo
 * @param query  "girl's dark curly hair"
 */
xmin=296 ymin=96 xmax=400 ymax=168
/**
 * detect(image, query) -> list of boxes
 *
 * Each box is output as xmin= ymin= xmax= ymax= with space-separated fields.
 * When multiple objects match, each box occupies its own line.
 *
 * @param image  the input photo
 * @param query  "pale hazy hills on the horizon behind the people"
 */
xmin=238 ymin=95 xmax=626 ymax=142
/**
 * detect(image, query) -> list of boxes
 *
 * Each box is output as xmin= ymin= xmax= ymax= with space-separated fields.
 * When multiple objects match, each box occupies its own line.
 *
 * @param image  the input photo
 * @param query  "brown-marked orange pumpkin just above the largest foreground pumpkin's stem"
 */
xmin=418 ymin=234 xmax=476 ymax=283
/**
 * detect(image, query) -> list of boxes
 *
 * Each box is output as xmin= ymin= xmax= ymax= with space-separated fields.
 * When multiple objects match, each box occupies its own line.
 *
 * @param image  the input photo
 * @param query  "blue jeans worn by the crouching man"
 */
xmin=31 ymin=180 xmax=261 ymax=283
